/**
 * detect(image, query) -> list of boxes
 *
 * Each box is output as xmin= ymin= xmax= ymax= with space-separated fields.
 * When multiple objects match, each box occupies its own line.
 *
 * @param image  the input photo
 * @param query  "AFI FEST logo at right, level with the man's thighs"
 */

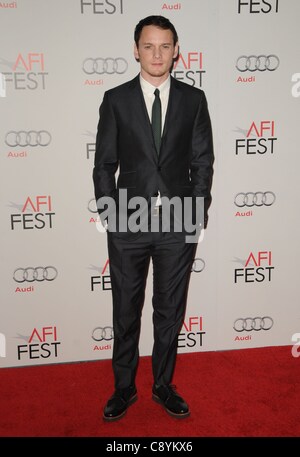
xmin=234 ymin=251 xmax=274 ymax=284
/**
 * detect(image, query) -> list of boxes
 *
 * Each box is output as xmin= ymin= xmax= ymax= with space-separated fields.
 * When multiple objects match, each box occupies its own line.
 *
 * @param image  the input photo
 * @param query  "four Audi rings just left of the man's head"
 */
xmin=82 ymin=57 xmax=128 ymax=75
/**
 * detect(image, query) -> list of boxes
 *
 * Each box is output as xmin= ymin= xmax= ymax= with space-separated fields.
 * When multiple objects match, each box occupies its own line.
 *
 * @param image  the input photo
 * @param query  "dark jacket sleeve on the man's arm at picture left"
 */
xmin=93 ymin=92 xmax=119 ymax=214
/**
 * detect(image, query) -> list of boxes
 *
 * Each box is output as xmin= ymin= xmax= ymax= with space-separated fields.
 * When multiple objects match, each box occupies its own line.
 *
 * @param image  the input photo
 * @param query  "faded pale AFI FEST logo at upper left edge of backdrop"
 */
xmin=1 ymin=52 xmax=48 ymax=91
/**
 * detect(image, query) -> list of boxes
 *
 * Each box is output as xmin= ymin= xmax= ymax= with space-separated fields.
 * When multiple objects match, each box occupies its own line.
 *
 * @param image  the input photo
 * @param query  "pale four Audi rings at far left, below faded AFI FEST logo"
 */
xmin=5 ymin=130 xmax=51 ymax=148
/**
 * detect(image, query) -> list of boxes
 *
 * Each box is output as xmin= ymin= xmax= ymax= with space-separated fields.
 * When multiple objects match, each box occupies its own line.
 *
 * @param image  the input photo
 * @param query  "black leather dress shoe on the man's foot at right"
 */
xmin=152 ymin=385 xmax=190 ymax=418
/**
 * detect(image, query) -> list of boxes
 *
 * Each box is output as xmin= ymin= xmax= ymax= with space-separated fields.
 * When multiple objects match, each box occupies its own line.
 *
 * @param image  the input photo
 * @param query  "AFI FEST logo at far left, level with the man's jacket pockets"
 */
xmin=10 ymin=195 xmax=55 ymax=230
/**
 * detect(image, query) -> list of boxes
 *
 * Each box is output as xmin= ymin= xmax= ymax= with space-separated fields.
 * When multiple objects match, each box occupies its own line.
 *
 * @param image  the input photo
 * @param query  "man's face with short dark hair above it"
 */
xmin=134 ymin=25 xmax=178 ymax=83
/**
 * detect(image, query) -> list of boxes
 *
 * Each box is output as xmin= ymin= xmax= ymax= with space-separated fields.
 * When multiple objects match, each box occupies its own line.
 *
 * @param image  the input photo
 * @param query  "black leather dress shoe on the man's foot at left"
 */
xmin=103 ymin=387 xmax=137 ymax=421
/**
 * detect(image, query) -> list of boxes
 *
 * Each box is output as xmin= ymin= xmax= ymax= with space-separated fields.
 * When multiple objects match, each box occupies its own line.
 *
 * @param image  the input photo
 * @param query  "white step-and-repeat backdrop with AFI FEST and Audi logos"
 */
xmin=0 ymin=0 xmax=300 ymax=367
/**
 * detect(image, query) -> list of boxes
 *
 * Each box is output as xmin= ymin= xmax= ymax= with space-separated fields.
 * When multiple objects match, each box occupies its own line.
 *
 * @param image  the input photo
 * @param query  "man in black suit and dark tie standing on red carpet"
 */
xmin=93 ymin=16 xmax=214 ymax=421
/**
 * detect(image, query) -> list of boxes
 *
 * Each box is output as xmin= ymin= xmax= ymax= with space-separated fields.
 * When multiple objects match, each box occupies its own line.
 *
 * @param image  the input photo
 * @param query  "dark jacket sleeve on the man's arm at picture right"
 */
xmin=190 ymin=92 xmax=214 ymax=227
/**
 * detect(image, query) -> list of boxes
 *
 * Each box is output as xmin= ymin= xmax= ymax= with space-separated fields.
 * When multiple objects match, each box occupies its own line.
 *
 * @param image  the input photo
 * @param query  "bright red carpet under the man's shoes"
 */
xmin=0 ymin=346 xmax=300 ymax=437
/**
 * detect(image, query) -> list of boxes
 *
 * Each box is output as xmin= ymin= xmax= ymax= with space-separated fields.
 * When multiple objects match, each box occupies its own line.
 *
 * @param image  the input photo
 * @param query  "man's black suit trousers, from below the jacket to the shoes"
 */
xmin=107 ymin=221 xmax=197 ymax=389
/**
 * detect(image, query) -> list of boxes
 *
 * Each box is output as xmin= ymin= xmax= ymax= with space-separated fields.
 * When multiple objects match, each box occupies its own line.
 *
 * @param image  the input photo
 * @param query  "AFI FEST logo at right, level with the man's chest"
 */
xmin=235 ymin=120 xmax=277 ymax=157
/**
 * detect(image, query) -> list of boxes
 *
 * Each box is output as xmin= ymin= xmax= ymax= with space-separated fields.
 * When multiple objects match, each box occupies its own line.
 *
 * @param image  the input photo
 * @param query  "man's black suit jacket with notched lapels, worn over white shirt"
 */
xmin=93 ymin=75 xmax=214 ymax=233
